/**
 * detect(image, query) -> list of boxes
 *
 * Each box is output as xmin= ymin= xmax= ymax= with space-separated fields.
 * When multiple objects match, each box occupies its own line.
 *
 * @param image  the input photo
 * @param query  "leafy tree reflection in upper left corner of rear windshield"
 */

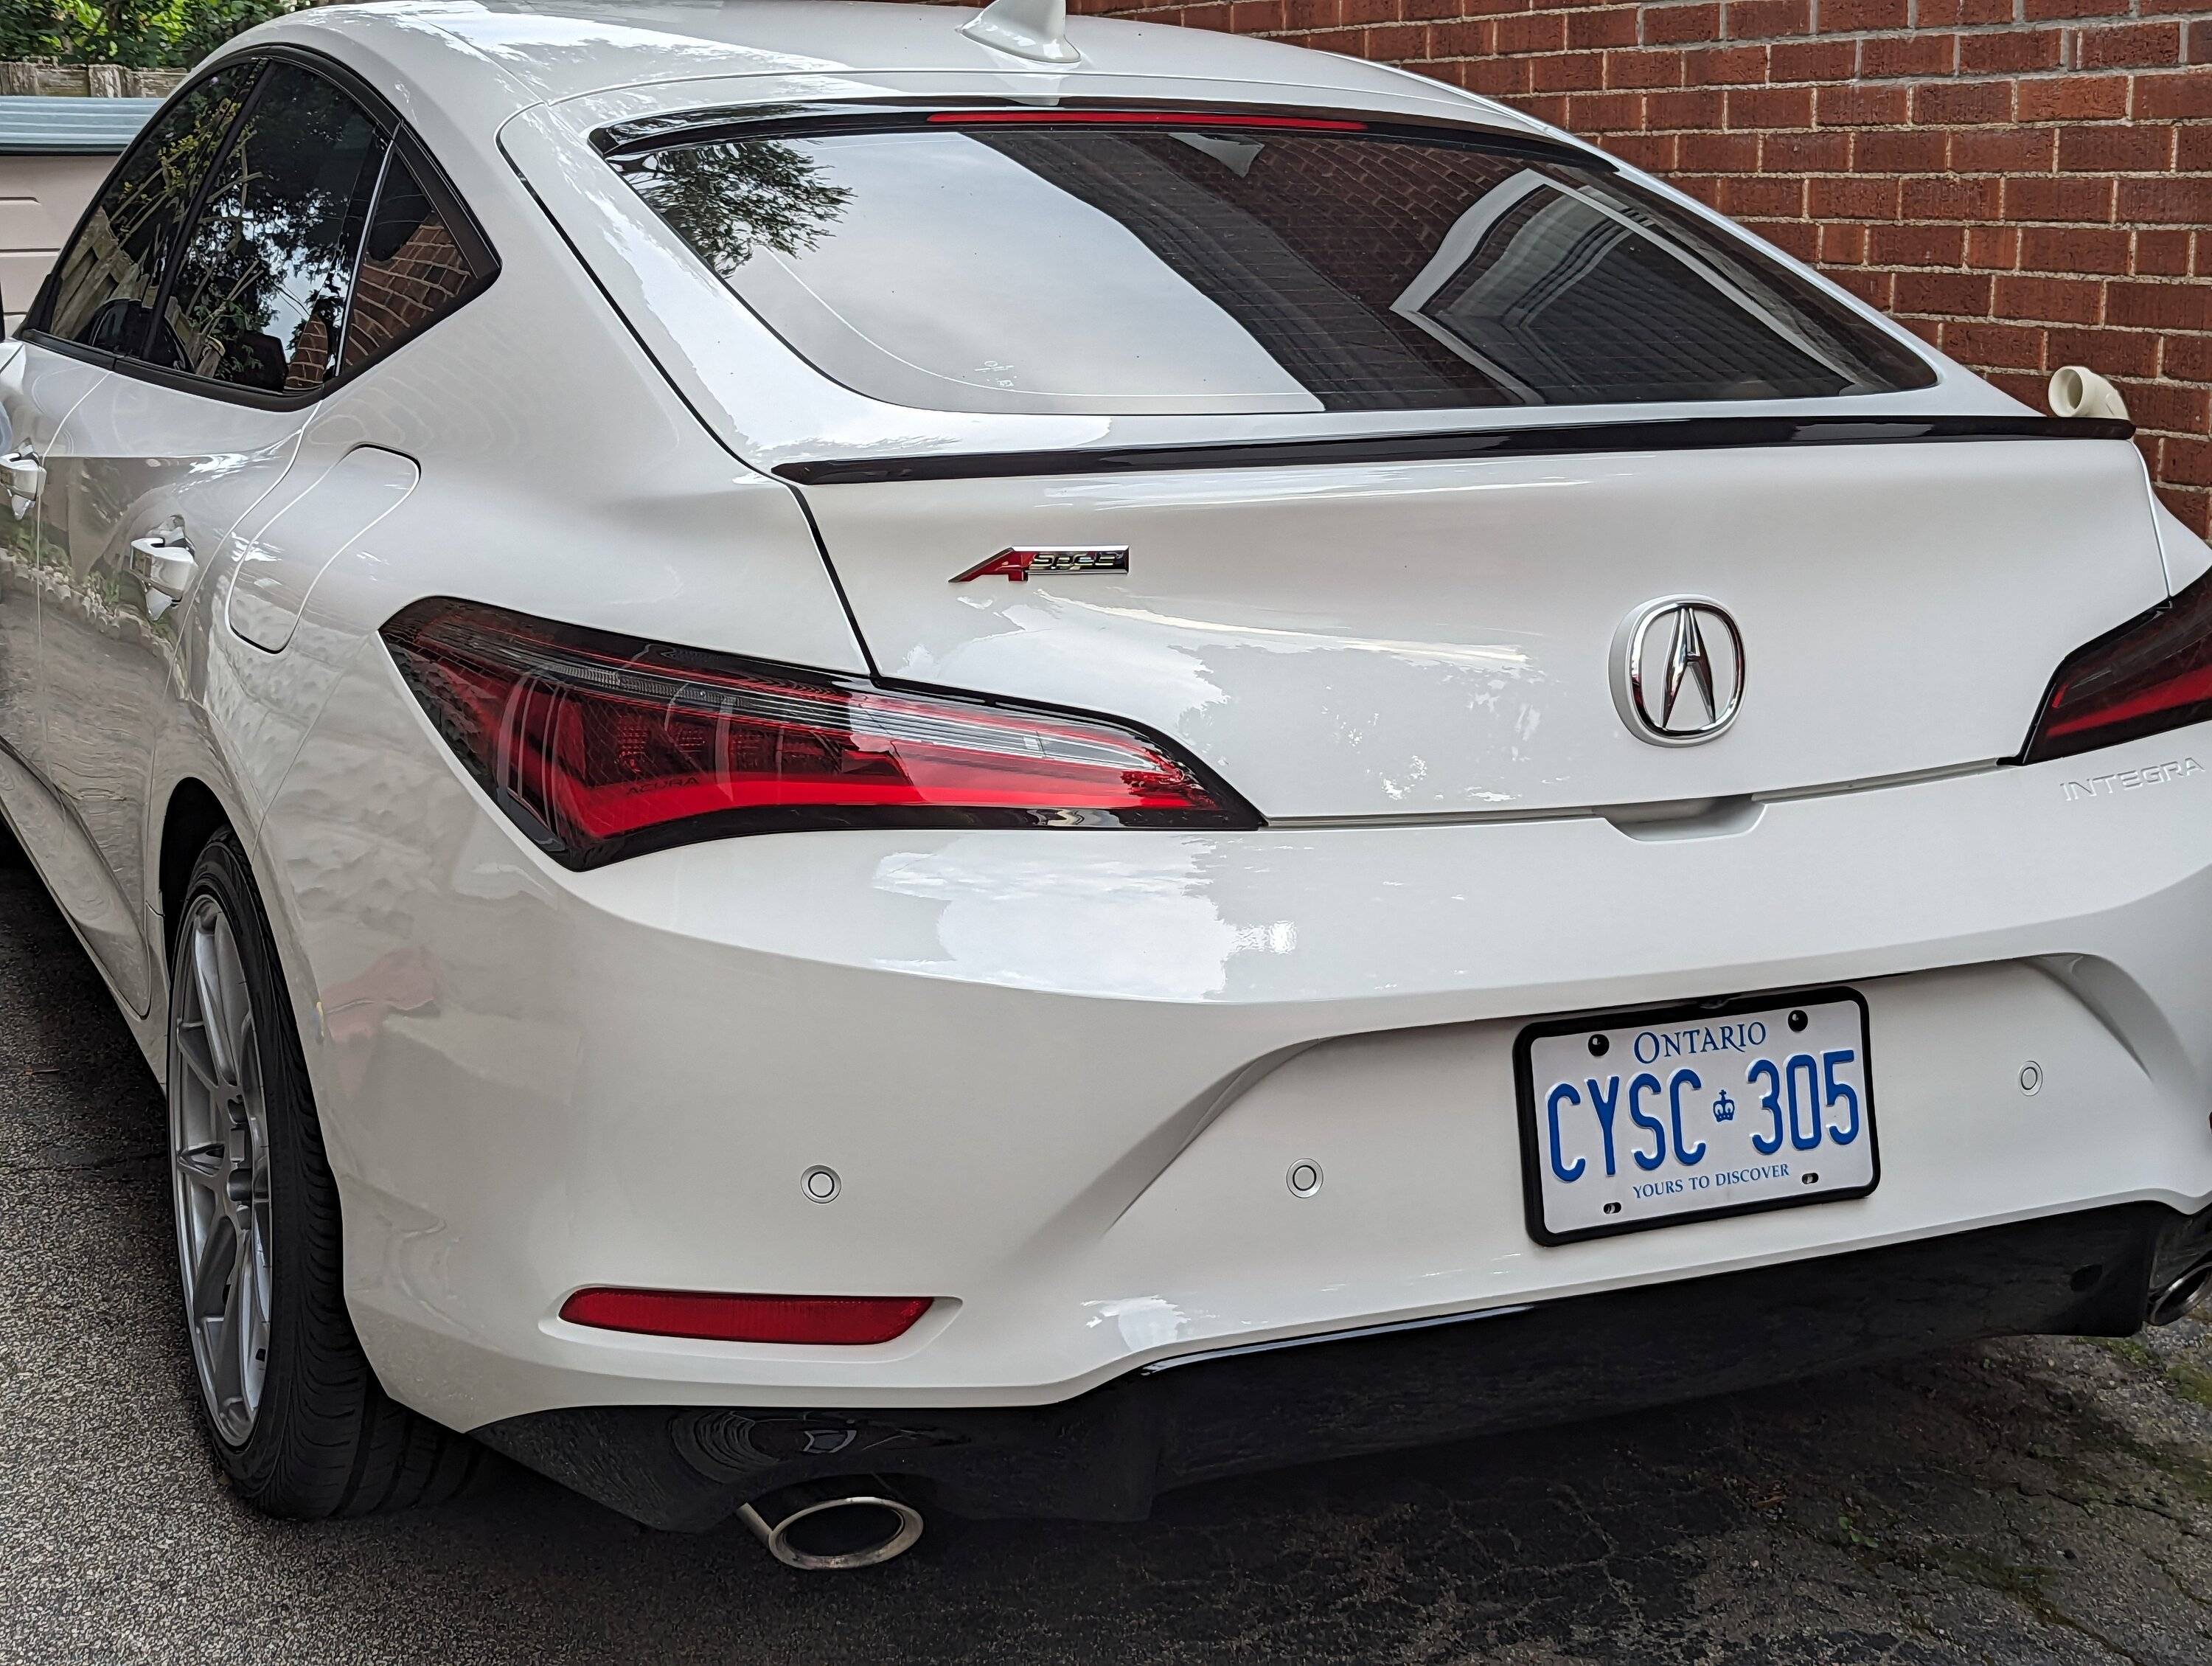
xmin=622 ymin=139 xmax=852 ymax=277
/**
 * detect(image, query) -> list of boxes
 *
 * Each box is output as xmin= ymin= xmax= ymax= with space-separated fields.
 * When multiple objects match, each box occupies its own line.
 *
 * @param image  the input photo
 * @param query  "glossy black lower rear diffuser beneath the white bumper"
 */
xmin=478 ymin=1204 xmax=2212 ymax=1529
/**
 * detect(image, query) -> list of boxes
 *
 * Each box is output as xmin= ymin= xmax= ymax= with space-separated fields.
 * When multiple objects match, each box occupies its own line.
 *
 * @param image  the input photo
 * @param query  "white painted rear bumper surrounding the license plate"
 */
xmin=263 ymin=650 xmax=2212 ymax=1427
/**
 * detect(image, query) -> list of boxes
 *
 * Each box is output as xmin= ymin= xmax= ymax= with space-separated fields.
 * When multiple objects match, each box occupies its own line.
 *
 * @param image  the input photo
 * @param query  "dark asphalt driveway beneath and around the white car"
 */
xmin=0 ymin=858 xmax=2212 ymax=1666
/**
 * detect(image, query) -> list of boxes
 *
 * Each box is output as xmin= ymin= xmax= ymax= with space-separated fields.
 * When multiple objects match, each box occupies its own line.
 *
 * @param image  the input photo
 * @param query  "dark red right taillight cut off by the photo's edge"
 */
xmin=2020 ymin=575 xmax=2212 ymax=763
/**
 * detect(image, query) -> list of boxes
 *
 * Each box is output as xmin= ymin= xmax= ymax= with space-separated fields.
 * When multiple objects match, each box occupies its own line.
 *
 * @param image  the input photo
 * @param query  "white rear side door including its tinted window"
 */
xmin=40 ymin=60 xmax=389 ymax=1009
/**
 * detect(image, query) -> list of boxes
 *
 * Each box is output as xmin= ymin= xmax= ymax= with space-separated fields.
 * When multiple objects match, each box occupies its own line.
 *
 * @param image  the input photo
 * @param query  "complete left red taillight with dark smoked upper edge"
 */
xmin=383 ymin=600 xmax=1259 ymax=867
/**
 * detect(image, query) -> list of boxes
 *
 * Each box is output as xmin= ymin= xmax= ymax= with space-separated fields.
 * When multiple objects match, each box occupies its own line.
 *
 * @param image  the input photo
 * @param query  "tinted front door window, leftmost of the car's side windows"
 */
xmin=44 ymin=64 xmax=254 ymax=352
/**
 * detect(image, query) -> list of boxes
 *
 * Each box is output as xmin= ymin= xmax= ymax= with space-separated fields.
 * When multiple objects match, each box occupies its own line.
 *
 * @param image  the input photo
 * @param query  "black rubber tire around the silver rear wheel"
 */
xmin=168 ymin=832 xmax=487 ymax=1520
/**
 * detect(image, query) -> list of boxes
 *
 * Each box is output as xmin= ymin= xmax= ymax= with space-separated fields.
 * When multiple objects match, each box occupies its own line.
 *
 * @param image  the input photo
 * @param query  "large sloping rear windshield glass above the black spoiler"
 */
xmin=615 ymin=115 xmax=1935 ymax=414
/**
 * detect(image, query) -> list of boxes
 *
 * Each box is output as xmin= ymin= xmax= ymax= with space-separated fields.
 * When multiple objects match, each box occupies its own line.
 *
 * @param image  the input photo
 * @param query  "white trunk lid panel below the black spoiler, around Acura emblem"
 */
xmin=803 ymin=438 xmax=2166 ymax=821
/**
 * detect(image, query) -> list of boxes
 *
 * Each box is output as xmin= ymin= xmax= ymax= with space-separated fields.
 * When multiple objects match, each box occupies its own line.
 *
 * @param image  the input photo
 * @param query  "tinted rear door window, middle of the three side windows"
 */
xmin=146 ymin=64 xmax=385 ymax=394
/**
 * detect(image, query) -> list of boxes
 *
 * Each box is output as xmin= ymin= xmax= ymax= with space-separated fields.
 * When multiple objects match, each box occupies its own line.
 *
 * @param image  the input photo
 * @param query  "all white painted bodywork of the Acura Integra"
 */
xmin=0 ymin=2 xmax=2212 ymax=1513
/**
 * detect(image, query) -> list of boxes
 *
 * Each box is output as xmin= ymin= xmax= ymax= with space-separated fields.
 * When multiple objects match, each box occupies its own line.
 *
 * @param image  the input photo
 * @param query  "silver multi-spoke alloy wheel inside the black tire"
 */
xmin=168 ymin=892 xmax=270 ymax=1447
